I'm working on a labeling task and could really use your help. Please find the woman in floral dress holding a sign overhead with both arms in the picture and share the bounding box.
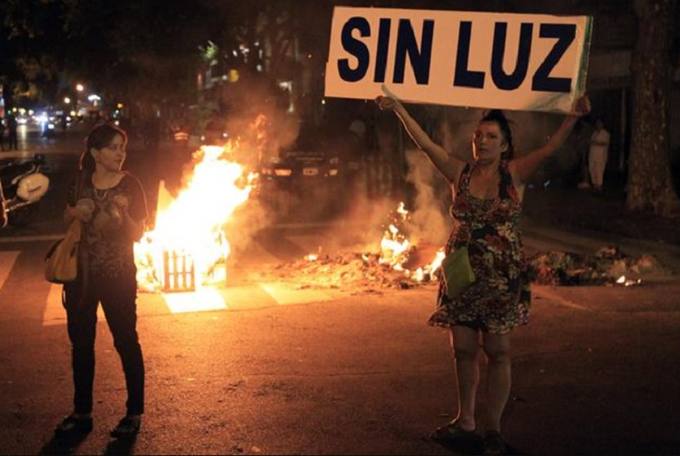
[376,89,590,454]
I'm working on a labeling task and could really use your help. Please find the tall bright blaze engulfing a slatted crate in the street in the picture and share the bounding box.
[135,142,256,291]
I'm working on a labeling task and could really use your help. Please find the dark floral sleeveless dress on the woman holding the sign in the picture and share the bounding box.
[429,160,531,334]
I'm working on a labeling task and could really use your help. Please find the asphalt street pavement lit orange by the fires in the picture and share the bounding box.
[0,128,680,455]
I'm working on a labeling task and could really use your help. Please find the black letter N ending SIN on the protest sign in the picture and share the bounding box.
[393,19,434,84]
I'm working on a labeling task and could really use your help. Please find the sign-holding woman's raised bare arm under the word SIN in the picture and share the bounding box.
[375,96,465,183]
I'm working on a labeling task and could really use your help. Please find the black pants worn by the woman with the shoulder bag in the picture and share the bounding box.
[64,273,144,415]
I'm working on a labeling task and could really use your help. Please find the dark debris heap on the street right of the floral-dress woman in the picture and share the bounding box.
[529,246,663,286]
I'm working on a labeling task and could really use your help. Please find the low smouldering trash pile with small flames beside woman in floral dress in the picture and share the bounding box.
[250,202,444,291]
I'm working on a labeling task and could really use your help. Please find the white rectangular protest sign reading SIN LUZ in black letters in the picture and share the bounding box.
[325,7,592,112]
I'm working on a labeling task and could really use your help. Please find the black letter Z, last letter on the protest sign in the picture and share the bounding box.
[531,24,576,93]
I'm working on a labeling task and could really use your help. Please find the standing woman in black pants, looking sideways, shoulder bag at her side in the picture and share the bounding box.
[55,124,147,438]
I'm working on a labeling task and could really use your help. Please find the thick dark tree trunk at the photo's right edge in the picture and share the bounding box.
[626,0,680,216]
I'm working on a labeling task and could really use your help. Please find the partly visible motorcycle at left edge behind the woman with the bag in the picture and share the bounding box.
[0,154,50,228]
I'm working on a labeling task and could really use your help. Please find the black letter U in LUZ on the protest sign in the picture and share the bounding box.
[491,22,534,90]
